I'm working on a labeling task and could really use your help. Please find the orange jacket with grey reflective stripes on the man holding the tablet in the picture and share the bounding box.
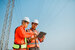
[27,29,43,48]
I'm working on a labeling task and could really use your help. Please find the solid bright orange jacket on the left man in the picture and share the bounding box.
[14,25,30,45]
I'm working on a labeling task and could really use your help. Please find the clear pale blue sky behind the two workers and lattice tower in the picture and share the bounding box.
[0,0,75,50]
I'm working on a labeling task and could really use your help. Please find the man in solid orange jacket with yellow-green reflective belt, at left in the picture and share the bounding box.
[13,17,31,50]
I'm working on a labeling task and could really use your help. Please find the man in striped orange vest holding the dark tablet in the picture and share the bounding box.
[26,19,45,50]
